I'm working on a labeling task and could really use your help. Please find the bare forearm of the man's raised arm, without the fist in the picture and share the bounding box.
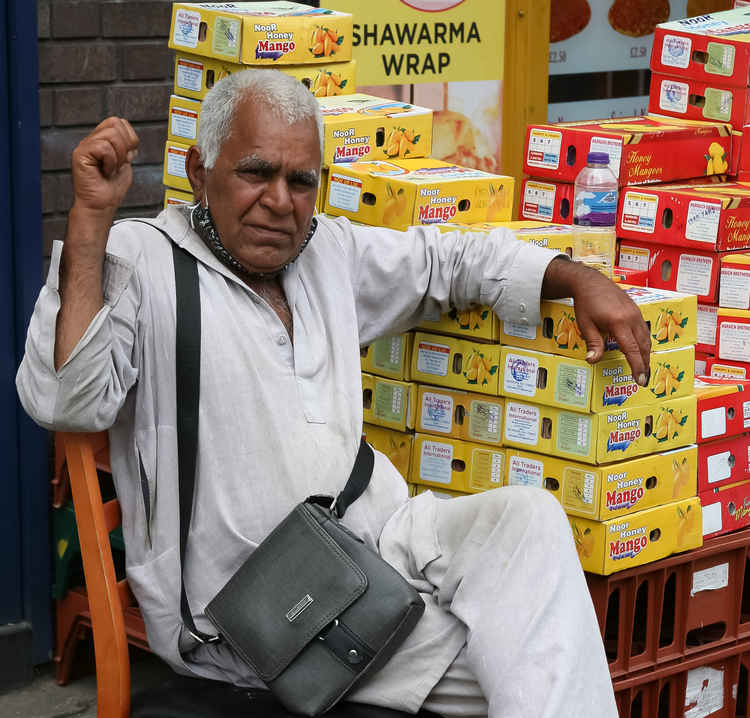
[55,206,112,370]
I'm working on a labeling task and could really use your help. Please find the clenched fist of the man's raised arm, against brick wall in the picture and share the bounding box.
[72,117,138,224]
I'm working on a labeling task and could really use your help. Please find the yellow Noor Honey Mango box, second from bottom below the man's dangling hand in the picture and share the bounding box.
[505,444,698,521]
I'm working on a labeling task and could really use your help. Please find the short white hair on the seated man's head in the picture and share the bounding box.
[197,69,323,170]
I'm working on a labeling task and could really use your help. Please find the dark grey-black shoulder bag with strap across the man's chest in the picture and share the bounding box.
[172,243,424,716]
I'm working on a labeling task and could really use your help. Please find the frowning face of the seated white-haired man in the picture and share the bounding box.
[205,98,321,272]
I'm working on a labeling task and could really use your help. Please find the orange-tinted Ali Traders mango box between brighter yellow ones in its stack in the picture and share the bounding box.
[416,384,503,446]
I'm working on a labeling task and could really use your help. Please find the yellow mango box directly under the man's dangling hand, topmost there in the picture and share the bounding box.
[500,285,698,358]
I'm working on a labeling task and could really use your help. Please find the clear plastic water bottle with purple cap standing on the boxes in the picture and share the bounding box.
[573,152,617,278]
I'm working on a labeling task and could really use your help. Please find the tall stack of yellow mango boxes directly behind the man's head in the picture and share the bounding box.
[164,0,356,208]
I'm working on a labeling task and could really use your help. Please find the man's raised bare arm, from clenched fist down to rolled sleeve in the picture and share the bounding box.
[55,117,138,369]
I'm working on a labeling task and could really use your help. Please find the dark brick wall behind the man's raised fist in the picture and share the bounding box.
[38,0,178,257]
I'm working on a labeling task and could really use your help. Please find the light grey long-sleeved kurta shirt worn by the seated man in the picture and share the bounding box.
[17,208,556,710]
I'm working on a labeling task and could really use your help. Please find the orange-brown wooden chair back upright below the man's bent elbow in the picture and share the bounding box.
[55,432,130,718]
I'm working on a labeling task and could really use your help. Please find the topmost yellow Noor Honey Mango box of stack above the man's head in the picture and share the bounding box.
[169,2,352,66]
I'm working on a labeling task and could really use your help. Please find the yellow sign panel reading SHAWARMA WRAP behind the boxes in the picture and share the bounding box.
[328,0,505,85]
